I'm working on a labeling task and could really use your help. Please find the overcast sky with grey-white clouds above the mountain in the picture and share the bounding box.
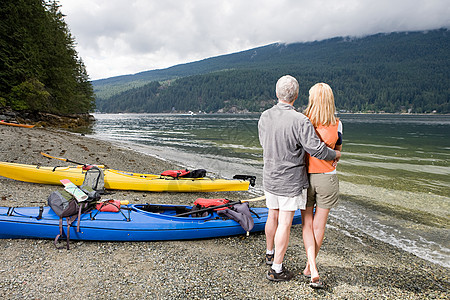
[60,0,450,80]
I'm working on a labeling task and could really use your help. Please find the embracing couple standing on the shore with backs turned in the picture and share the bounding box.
[258,75,342,288]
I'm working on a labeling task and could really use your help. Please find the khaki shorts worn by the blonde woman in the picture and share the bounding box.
[306,174,339,209]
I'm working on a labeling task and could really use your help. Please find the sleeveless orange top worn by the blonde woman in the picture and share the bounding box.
[307,120,339,173]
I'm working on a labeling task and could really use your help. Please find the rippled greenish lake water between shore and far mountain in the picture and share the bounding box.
[89,114,450,267]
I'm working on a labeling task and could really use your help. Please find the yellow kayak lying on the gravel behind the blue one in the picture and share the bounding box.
[0,162,250,192]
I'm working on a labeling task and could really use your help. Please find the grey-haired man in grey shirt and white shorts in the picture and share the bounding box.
[258,75,341,281]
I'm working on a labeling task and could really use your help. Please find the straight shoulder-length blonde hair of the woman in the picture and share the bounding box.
[304,82,336,127]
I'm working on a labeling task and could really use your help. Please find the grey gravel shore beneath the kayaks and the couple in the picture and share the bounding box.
[0,126,450,299]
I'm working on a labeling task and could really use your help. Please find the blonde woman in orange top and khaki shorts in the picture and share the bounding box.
[301,83,342,288]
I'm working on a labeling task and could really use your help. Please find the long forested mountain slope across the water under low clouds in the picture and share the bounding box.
[93,29,450,113]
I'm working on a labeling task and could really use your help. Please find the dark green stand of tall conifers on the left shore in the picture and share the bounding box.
[0,0,95,114]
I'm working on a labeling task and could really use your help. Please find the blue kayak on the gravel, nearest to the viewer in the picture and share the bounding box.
[0,204,301,241]
